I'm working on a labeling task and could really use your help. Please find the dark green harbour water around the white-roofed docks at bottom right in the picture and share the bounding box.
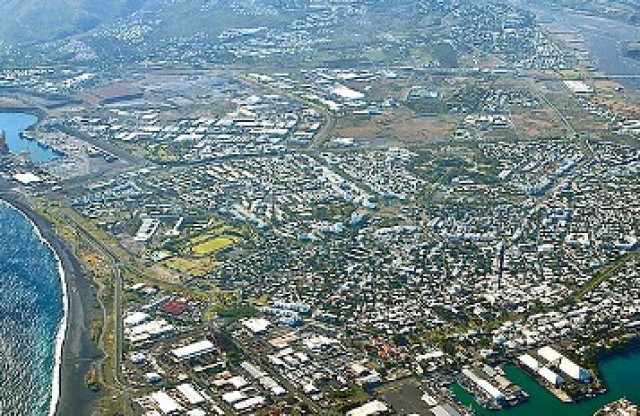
[451,352,640,416]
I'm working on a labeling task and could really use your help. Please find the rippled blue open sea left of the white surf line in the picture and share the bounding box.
[0,201,64,416]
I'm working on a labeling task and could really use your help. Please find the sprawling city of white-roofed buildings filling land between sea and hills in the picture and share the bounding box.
[0,0,640,416]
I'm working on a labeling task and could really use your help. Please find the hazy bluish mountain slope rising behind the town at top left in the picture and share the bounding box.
[0,0,308,44]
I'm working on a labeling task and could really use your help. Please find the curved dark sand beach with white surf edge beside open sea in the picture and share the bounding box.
[0,186,102,416]
